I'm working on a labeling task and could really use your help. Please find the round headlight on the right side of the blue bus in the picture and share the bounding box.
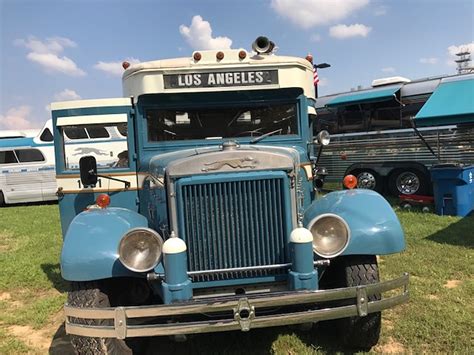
[308,213,350,258]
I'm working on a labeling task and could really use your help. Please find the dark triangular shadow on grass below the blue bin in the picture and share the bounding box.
[427,216,474,249]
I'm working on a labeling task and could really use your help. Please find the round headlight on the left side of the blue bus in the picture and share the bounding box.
[118,228,163,272]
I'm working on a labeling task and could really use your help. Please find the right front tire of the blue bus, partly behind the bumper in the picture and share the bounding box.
[322,255,382,351]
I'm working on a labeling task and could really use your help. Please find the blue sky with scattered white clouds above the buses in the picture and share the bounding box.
[0,0,474,129]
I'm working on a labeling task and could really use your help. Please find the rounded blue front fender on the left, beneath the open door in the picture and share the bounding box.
[61,207,148,281]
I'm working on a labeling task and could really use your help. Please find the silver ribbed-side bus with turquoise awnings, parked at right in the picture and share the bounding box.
[315,74,474,196]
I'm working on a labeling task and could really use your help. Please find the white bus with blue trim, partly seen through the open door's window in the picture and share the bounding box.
[0,120,127,205]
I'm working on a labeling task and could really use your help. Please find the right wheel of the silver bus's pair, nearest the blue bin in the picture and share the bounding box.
[388,169,429,197]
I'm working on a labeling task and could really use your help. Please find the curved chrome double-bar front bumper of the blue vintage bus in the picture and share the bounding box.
[64,273,409,339]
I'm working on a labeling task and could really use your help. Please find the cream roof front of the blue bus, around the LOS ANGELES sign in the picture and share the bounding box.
[122,49,315,100]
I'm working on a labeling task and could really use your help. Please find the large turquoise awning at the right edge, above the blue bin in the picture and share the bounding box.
[415,75,474,126]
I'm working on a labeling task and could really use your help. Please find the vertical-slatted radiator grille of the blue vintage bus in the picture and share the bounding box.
[178,177,287,282]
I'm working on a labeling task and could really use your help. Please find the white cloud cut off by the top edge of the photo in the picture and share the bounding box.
[271,0,369,28]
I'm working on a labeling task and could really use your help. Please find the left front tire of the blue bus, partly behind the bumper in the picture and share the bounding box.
[67,279,150,355]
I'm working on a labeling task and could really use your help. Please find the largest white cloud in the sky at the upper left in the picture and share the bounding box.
[14,37,86,76]
